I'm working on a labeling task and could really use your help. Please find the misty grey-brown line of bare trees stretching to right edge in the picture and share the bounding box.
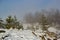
[24,9,60,30]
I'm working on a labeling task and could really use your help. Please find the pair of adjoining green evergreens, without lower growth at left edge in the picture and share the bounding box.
[6,16,23,29]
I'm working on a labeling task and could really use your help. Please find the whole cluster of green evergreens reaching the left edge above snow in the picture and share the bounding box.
[0,16,23,29]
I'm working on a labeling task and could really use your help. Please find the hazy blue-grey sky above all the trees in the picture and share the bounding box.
[0,0,60,19]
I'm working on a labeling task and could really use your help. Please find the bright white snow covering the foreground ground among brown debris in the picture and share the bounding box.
[0,28,60,40]
